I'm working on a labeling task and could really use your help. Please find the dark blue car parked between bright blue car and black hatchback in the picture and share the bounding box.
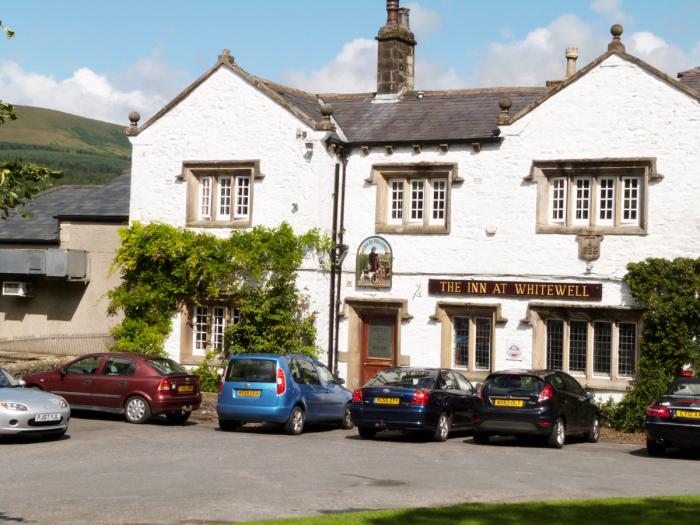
[352,367,476,441]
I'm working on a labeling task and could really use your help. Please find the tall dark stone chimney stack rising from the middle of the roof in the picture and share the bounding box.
[376,0,416,95]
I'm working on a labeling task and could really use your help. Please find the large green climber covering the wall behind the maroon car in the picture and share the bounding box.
[108,222,330,355]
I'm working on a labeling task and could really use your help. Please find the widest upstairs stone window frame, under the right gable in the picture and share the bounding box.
[525,157,663,235]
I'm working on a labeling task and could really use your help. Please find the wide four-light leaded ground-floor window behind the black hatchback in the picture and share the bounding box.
[543,312,639,378]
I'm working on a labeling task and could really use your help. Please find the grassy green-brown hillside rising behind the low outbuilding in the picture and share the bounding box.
[0,106,131,184]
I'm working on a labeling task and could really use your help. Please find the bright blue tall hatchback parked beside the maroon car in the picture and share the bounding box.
[216,354,353,435]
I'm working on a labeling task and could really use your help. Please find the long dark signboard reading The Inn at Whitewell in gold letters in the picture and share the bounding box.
[428,279,603,301]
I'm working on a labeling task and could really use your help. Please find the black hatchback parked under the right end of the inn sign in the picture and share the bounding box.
[473,370,600,448]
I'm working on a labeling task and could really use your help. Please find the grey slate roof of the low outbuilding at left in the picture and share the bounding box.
[0,171,131,244]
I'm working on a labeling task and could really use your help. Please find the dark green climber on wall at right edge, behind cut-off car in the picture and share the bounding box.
[608,258,700,431]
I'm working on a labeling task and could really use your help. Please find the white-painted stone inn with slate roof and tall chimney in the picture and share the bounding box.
[129,1,700,393]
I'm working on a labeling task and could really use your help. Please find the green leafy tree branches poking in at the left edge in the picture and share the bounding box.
[0,20,63,216]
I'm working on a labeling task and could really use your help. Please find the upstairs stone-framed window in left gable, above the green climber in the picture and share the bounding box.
[183,161,262,228]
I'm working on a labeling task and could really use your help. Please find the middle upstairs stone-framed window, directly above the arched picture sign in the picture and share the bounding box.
[366,163,463,234]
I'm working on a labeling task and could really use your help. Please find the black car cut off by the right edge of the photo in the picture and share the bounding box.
[647,377,700,456]
